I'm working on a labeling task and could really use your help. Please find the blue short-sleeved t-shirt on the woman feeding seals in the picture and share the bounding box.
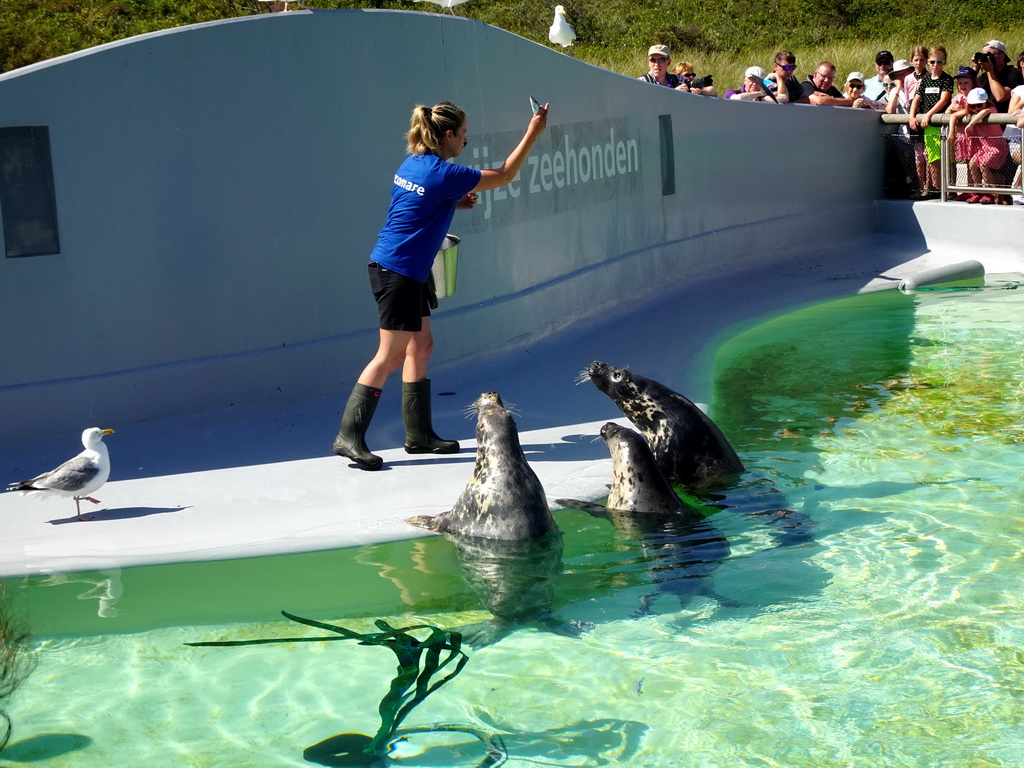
[370,155,482,283]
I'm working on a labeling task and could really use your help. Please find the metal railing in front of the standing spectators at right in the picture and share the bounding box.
[881,114,1024,201]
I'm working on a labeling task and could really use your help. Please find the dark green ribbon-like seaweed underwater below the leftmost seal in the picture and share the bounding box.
[185,610,508,768]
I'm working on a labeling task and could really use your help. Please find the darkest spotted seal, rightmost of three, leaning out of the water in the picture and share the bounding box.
[583,360,743,488]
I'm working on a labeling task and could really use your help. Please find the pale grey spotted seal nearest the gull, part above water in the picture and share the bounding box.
[406,392,557,541]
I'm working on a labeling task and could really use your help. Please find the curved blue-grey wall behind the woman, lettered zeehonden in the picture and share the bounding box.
[0,11,882,439]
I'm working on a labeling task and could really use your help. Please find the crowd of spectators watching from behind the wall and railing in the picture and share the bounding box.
[638,40,1024,205]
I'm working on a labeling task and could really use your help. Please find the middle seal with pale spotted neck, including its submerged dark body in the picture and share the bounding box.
[556,422,732,615]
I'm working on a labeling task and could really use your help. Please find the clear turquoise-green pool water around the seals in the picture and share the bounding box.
[0,278,1024,768]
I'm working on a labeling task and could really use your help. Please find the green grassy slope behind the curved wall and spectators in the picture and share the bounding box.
[0,0,1024,92]
